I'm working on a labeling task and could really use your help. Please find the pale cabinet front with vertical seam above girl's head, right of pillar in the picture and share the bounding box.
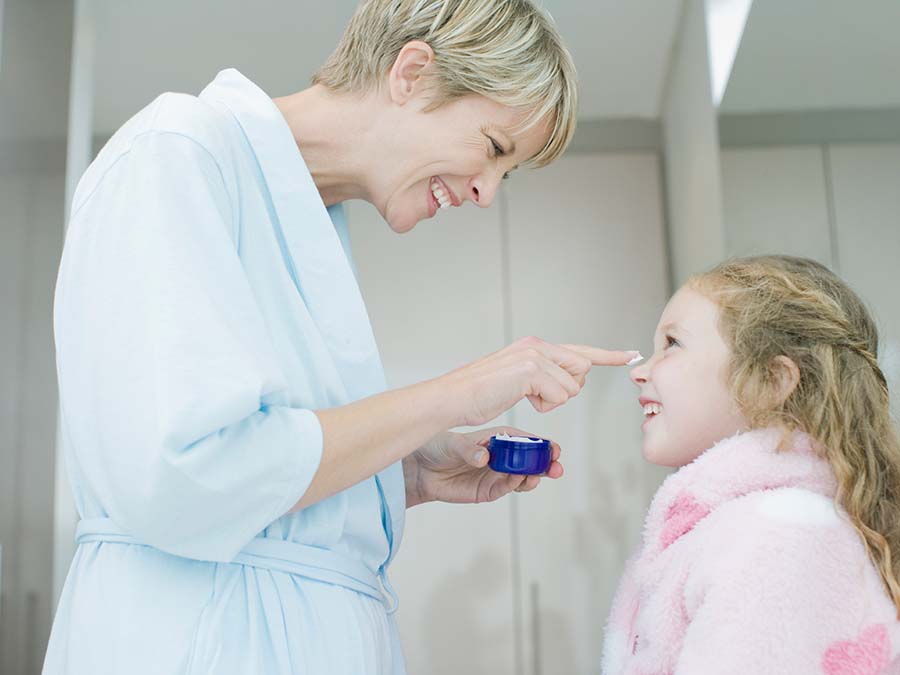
[722,144,900,419]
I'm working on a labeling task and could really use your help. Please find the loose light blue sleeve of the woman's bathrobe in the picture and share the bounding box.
[55,131,322,561]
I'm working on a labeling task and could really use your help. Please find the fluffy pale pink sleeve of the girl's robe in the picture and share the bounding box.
[675,496,880,675]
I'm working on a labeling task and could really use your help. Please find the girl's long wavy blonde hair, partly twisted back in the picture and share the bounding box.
[688,255,900,618]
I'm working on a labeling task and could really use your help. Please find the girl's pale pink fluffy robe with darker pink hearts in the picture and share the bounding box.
[603,429,900,675]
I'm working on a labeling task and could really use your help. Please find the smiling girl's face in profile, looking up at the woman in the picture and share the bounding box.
[631,287,747,467]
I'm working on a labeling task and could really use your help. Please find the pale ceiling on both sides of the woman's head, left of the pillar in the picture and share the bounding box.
[94,0,682,133]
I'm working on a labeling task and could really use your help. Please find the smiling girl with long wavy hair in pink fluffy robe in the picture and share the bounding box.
[603,256,900,675]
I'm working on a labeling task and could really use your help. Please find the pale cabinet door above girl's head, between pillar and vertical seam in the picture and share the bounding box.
[721,147,832,266]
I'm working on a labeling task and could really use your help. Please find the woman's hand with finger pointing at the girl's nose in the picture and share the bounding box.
[438,337,639,426]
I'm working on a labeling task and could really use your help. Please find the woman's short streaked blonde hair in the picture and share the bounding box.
[313,0,578,166]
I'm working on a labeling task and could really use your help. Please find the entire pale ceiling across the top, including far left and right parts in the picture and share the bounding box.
[0,0,900,139]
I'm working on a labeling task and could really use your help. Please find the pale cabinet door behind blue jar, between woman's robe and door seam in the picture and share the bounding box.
[348,202,513,675]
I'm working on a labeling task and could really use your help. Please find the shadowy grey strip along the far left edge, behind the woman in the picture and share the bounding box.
[0,0,72,675]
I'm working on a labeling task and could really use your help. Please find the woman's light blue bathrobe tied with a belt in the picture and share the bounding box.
[44,70,406,675]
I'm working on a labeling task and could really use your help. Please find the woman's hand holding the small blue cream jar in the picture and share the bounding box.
[403,427,563,508]
